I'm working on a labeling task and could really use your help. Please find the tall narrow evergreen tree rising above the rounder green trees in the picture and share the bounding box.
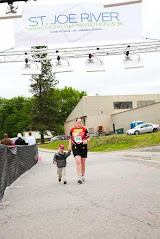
[30,46,58,143]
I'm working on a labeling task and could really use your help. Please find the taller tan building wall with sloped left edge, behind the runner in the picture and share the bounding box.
[65,94,159,135]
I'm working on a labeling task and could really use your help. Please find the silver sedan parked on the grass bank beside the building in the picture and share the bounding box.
[126,123,159,135]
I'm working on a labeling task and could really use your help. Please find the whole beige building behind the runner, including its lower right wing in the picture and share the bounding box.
[64,94,160,135]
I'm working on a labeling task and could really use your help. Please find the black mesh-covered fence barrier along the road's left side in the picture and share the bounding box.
[0,144,38,202]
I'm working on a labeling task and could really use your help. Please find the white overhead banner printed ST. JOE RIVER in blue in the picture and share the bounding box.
[14,3,142,47]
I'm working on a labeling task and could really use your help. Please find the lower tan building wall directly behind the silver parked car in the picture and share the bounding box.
[111,103,160,133]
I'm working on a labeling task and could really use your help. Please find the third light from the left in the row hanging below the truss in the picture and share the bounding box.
[85,54,105,72]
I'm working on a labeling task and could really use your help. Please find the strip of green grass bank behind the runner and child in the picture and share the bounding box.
[39,132,160,152]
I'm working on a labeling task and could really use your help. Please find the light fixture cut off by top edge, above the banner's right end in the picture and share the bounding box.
[103,0,143,7]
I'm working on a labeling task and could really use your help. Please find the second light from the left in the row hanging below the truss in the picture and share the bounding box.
[52,55,73,73]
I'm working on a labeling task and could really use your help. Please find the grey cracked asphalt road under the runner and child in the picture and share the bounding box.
[0,146,160,239]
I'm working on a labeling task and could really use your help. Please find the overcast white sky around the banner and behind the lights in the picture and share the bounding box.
[0,0,160,99]
